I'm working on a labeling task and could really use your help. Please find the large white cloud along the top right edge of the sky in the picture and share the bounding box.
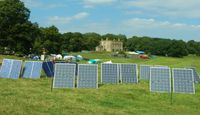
[124,0,200,18]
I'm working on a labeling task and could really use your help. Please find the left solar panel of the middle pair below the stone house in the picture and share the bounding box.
[101,64,119,84]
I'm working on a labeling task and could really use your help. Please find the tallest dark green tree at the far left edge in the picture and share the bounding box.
[0,0,32,53]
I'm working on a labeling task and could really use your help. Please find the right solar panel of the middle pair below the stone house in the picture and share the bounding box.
[119,63,138,83]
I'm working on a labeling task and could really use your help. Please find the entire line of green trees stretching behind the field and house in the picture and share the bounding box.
[0,0,200,57]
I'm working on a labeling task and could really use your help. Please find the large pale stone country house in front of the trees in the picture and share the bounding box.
[96,38,123,52]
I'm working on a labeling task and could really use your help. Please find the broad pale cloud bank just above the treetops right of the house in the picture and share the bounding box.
[123,18,200,39]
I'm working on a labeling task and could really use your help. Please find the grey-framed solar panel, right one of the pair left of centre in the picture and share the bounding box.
[77,64,98,88]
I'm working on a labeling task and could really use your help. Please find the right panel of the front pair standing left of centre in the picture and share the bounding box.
[77,64,98,88]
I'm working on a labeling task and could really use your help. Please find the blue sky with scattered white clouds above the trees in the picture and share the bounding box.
[22,0,200,41]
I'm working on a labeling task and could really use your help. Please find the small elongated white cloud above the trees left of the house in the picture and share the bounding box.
[48,12,89,25]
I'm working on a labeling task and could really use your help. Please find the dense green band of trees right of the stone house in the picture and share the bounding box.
[126,36,194,57]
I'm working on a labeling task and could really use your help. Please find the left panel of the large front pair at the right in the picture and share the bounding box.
[150,67,171,93]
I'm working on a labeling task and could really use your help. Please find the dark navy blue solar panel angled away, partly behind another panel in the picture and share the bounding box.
[42,61,54,77]
